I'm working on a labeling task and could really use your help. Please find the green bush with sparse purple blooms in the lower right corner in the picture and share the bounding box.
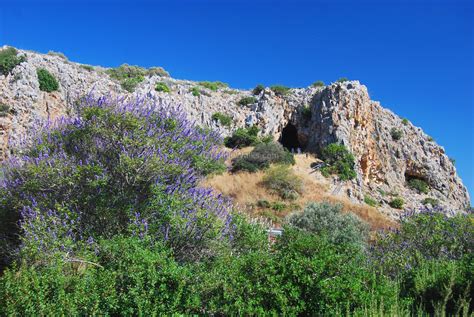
[371,208,474,316]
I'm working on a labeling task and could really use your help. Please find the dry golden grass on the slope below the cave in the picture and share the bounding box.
[202,148,397,230]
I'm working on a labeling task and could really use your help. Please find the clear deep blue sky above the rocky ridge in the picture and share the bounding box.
[0,0,474,200]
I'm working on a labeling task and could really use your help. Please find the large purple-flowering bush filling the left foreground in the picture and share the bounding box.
[0,95,232,264]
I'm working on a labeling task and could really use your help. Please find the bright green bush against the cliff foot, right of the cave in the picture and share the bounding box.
[321,143,357,180]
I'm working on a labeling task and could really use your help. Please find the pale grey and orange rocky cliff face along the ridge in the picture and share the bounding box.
[0,50,469,214]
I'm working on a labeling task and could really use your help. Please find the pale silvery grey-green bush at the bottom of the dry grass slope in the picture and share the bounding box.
[288,203,369,248]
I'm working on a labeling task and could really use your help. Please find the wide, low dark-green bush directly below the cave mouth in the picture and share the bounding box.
[232,142,295,172]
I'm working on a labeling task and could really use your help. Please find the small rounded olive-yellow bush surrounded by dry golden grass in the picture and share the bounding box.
[262,165,303,200]
